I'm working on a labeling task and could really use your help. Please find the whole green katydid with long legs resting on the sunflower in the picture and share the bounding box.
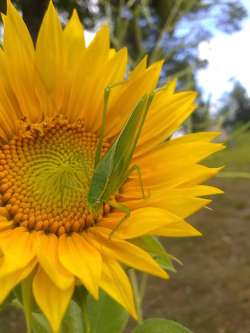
[87,88,153,237]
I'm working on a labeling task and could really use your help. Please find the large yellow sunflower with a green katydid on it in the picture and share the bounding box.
[0,2,222,332]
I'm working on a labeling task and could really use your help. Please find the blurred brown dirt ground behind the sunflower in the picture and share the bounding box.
[0,180,250,333]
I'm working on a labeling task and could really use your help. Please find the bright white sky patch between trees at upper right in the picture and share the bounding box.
[197,0,250,111]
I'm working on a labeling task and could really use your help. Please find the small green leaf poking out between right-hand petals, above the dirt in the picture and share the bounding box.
[132,236,176,272]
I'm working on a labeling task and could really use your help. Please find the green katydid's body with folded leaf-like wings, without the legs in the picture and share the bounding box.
[88,95,153,212]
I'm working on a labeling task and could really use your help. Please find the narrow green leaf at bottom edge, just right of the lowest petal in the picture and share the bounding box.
[60,301,84,333]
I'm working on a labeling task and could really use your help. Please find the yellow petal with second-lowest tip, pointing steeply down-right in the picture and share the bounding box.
[100,257,137,320]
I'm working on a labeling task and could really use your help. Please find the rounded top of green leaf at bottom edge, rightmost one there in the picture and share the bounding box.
[132,318,192,333]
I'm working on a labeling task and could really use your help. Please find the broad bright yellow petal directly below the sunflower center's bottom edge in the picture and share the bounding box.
[59,234,102,298]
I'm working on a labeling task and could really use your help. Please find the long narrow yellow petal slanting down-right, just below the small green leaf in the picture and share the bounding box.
[89,231,168,279]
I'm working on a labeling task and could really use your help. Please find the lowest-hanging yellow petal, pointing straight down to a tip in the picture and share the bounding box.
[33,269,74,333]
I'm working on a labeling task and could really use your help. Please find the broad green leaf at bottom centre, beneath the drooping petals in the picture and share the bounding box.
[88,291,129,333]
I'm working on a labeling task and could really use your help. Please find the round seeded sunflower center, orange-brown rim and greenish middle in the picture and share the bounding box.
[0,119,108,235]
